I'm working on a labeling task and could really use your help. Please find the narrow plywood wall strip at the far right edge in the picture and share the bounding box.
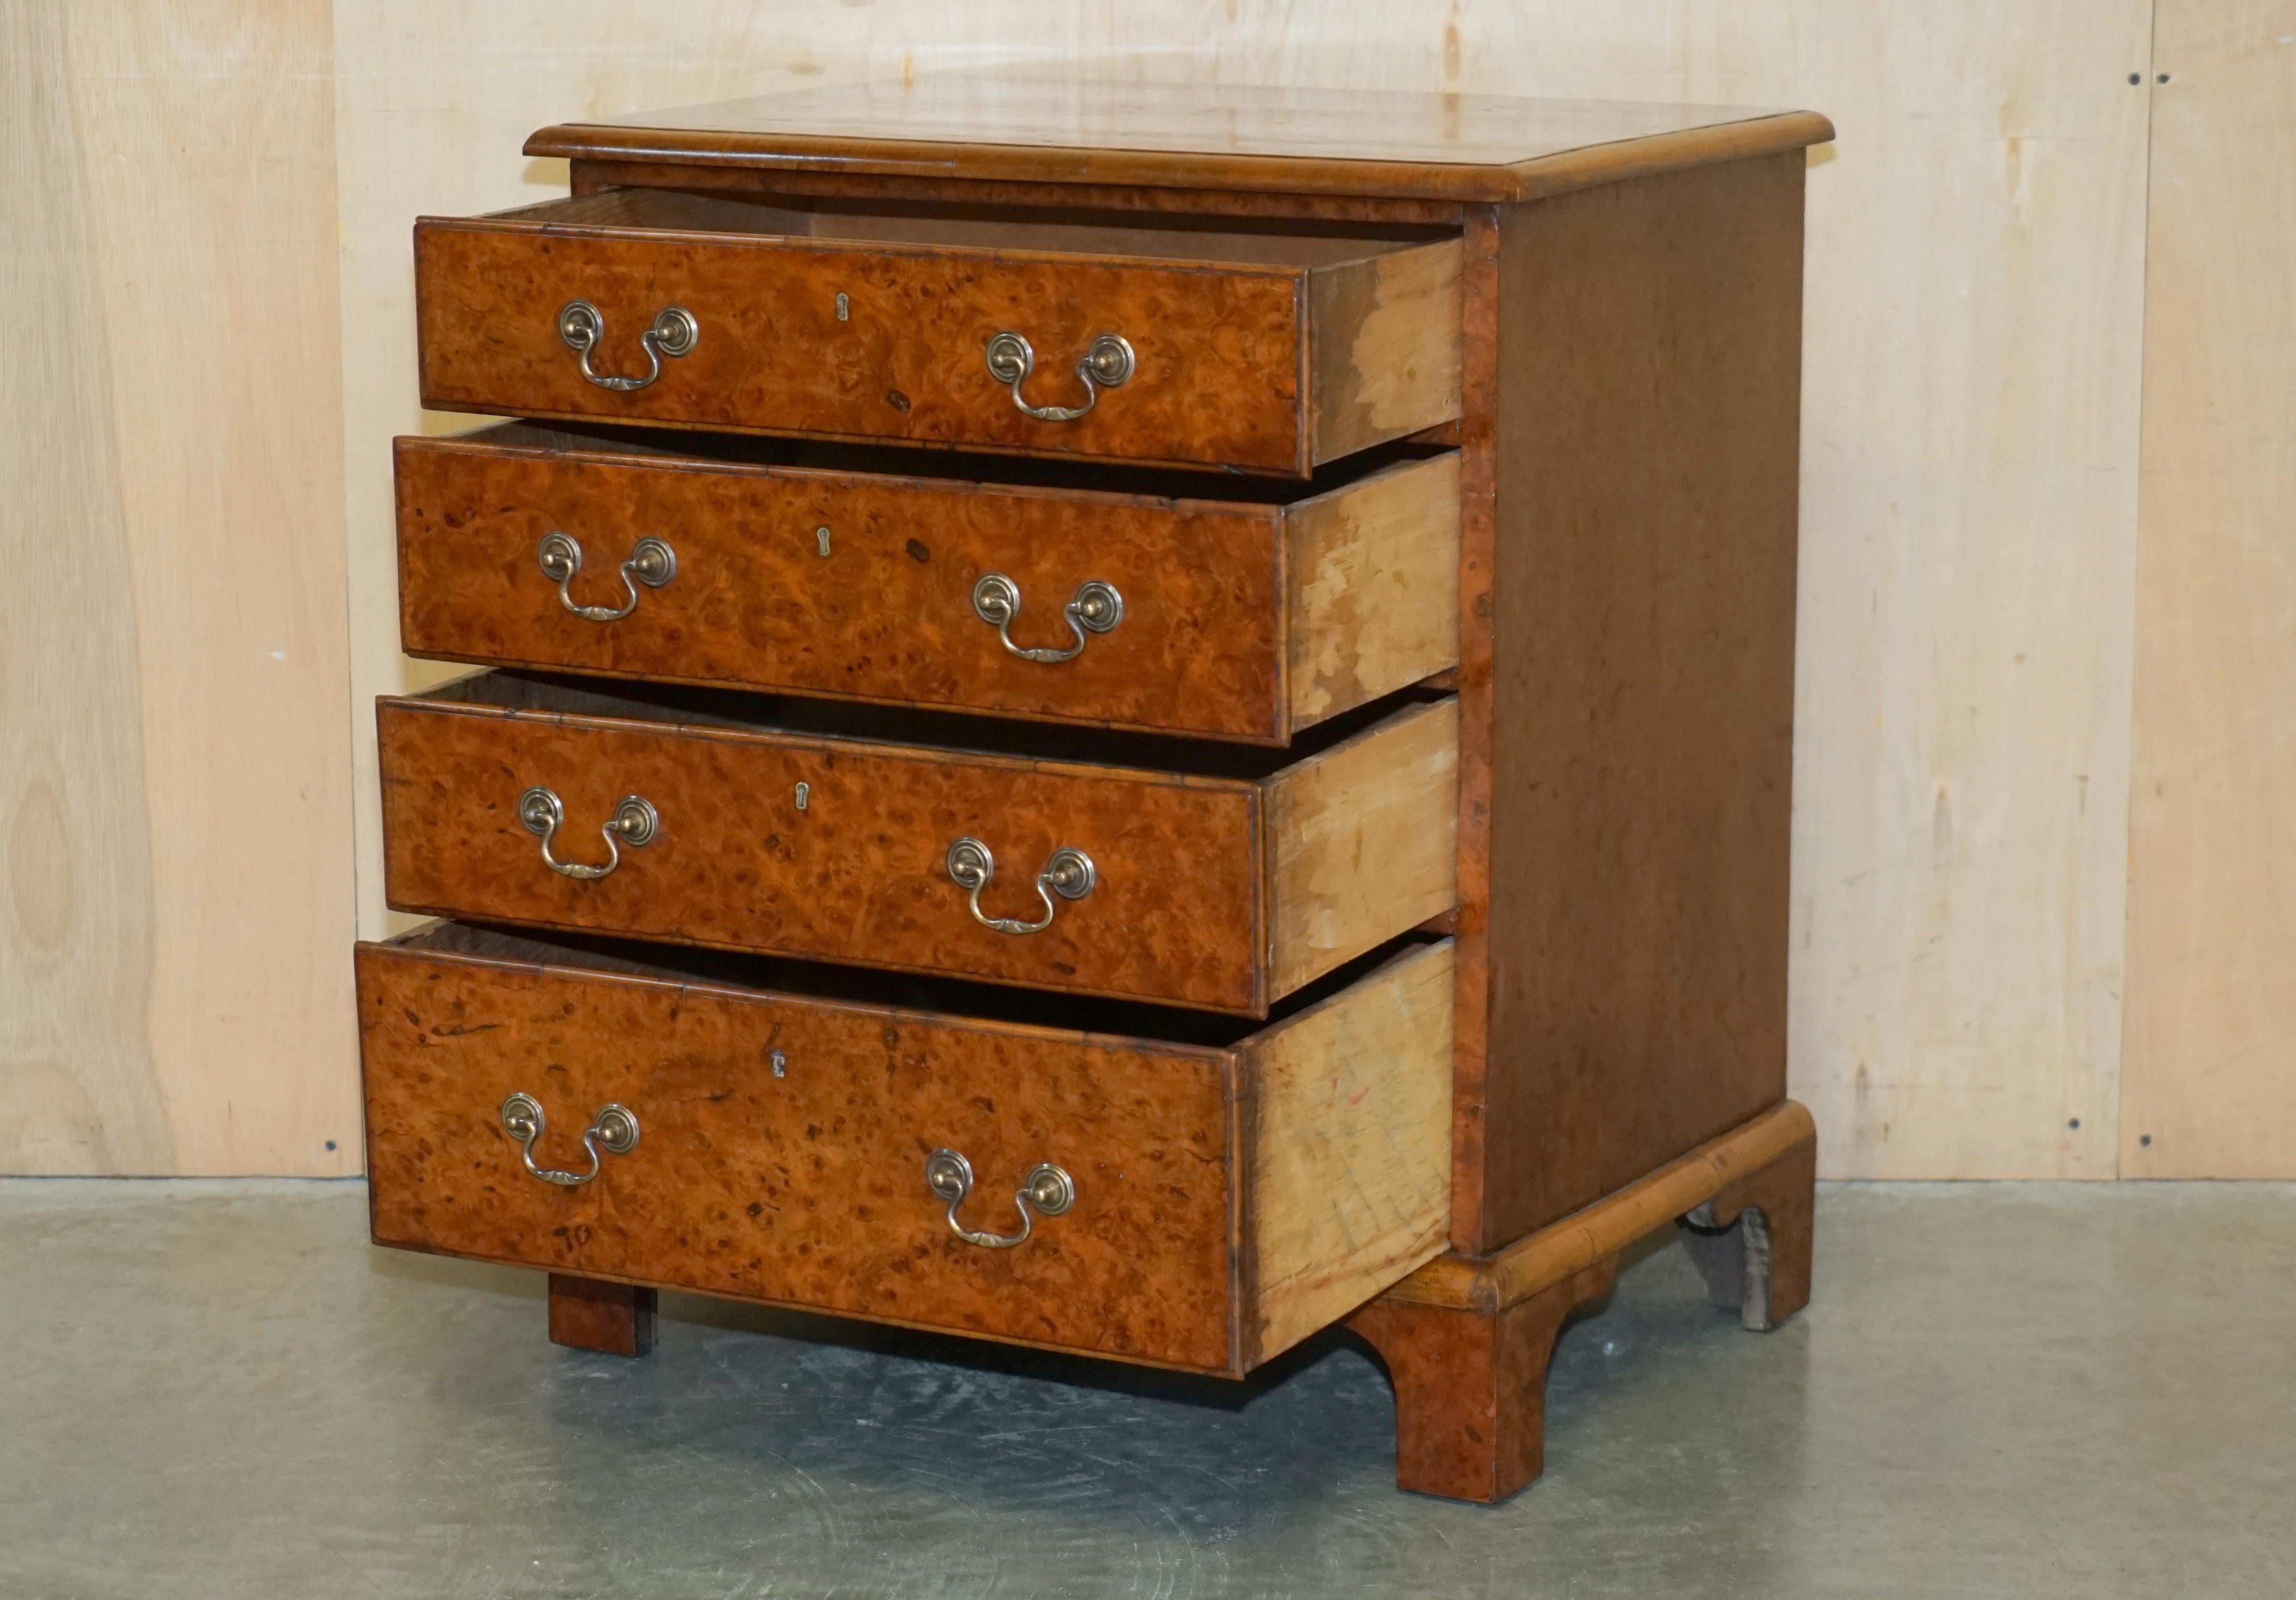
[2122,0,2296,1178]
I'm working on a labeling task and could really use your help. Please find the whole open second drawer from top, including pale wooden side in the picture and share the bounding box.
[397,425,1458,744]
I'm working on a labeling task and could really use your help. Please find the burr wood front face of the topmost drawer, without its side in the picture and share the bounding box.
[416,223,1307,473]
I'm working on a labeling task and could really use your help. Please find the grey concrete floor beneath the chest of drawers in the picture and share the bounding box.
[0,1180,2296,1600]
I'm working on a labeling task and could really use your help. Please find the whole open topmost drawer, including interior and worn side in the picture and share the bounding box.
[416,188,1460,475]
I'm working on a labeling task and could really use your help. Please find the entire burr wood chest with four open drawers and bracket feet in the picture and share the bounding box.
[358,76,1830,1499]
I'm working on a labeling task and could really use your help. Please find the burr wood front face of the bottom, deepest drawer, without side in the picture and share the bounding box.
[358,946,1233,1368]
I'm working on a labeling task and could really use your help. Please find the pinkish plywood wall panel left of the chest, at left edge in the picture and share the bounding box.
[0,0,358,1173]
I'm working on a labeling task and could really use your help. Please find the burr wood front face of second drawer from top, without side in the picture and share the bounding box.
[397,438,1286,739]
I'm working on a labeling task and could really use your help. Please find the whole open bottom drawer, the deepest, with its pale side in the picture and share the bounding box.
[358,923,1451,1373]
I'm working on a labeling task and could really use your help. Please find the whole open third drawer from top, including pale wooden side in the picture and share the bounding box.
[377,673,1458,1015]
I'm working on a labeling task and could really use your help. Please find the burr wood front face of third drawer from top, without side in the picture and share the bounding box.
[379,700,1265,1012]
